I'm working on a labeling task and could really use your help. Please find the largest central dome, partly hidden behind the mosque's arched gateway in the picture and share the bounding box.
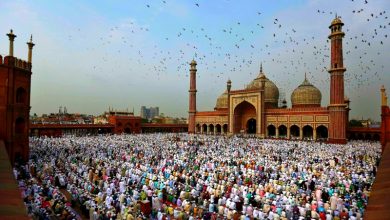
[246,67,279,106]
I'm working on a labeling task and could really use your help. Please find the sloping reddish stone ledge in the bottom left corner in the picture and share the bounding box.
[0,140,30,219]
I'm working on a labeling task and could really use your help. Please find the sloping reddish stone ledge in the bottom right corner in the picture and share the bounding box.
[364,143,390,220]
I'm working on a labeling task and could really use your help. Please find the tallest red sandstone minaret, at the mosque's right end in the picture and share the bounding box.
[328,15,347,144]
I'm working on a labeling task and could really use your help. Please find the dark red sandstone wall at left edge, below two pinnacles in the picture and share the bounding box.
[0,56,31,163]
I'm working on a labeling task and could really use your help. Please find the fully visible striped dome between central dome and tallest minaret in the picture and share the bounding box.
[291,74,322,107]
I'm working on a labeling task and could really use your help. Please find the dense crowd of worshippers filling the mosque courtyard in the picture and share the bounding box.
[15,134,381,220]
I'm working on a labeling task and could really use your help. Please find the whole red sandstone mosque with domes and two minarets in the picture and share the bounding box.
[188,16,350,144]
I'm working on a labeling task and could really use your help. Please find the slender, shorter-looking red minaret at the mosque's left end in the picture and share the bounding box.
[188,60,196,134]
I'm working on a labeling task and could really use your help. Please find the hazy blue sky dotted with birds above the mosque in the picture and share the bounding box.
[0,0,390,120]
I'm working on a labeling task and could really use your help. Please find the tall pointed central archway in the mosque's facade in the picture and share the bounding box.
[233,101,257,134]
